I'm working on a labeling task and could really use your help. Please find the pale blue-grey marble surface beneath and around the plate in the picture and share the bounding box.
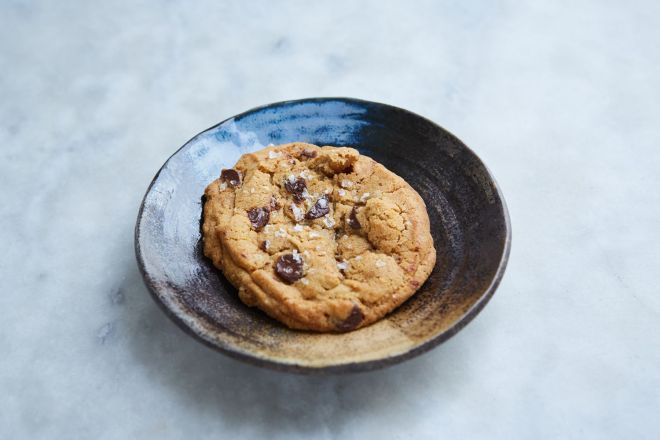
[0,0,660,439]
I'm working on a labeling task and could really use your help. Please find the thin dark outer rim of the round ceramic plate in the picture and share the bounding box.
[133,97,512,374]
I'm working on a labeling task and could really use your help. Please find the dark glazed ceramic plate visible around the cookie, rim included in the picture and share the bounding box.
[135,98,511,373]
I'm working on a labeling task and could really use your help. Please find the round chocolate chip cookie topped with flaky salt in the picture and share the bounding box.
[202,143,435,332]
